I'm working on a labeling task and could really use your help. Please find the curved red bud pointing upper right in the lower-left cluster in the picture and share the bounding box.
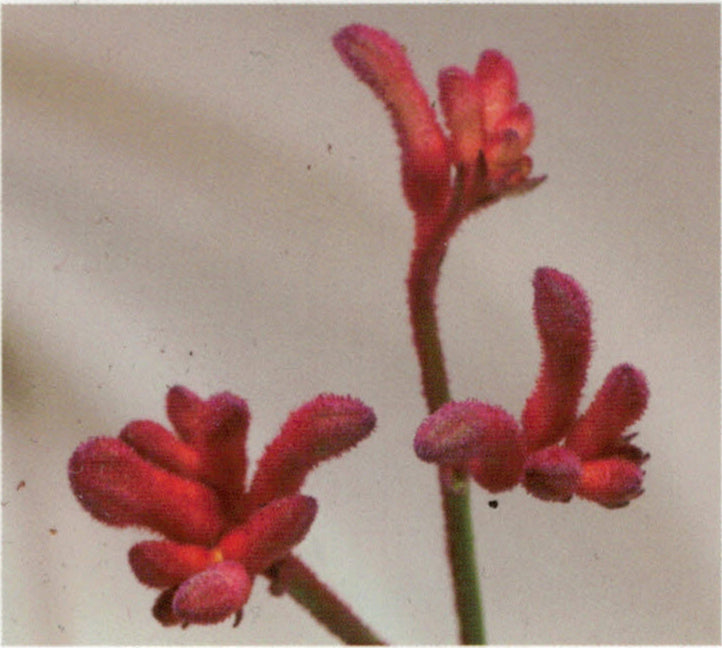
[249,394,376,507]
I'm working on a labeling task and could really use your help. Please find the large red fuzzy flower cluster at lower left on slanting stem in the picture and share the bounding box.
[68,386,376,625]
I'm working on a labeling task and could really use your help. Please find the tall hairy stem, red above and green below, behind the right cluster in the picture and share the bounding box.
[407,172,485,645]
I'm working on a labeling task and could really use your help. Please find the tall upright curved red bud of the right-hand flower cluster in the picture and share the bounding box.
[521,268,592,451]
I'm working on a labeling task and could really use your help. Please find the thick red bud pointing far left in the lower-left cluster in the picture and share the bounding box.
[68,437,225,544]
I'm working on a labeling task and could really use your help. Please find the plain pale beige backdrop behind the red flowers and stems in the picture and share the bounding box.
[2,5,720,644]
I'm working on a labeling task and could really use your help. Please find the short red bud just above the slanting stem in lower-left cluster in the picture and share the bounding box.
[218,495,318,574]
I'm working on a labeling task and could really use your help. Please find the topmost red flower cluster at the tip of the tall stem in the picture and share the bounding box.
[333,24,543,244]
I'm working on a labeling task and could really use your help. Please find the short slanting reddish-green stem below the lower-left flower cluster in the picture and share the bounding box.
[278,555,387,646]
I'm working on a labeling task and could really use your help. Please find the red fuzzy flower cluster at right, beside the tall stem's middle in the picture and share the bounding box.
[414,268,649,508]
